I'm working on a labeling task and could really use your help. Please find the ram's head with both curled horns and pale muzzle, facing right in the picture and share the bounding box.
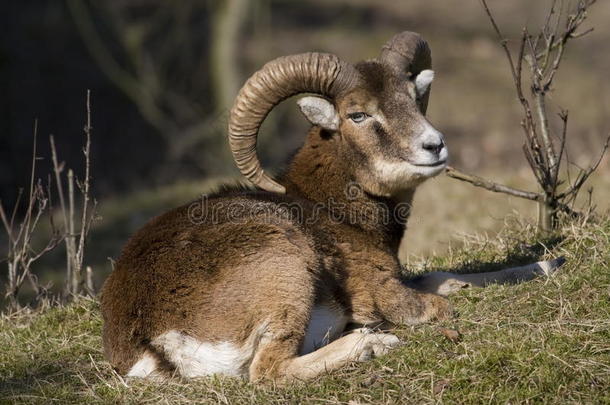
[229,32,447,196]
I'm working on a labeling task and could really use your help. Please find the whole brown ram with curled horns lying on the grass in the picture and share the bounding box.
[101,32,561,381]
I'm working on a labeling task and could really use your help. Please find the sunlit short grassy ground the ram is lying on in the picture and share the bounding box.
[0,218,610,404]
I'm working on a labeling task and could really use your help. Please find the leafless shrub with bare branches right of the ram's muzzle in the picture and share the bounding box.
[447,0,610,231]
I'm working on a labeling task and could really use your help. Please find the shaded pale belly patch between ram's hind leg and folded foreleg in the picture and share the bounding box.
[300,305,347,355]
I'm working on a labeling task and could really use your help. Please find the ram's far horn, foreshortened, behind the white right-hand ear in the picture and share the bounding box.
[379,31,432,114]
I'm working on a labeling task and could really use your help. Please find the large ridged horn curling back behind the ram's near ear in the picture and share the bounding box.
[229,52,357,193]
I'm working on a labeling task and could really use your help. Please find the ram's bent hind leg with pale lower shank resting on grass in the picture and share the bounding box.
[249,237,398,381]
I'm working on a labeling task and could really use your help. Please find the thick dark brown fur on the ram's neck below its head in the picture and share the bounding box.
[281,127,413,249]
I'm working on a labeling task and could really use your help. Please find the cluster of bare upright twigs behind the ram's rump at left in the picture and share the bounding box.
[0,91,96,310]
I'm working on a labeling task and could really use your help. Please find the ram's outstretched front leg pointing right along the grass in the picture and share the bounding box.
[408,256,566,296]
